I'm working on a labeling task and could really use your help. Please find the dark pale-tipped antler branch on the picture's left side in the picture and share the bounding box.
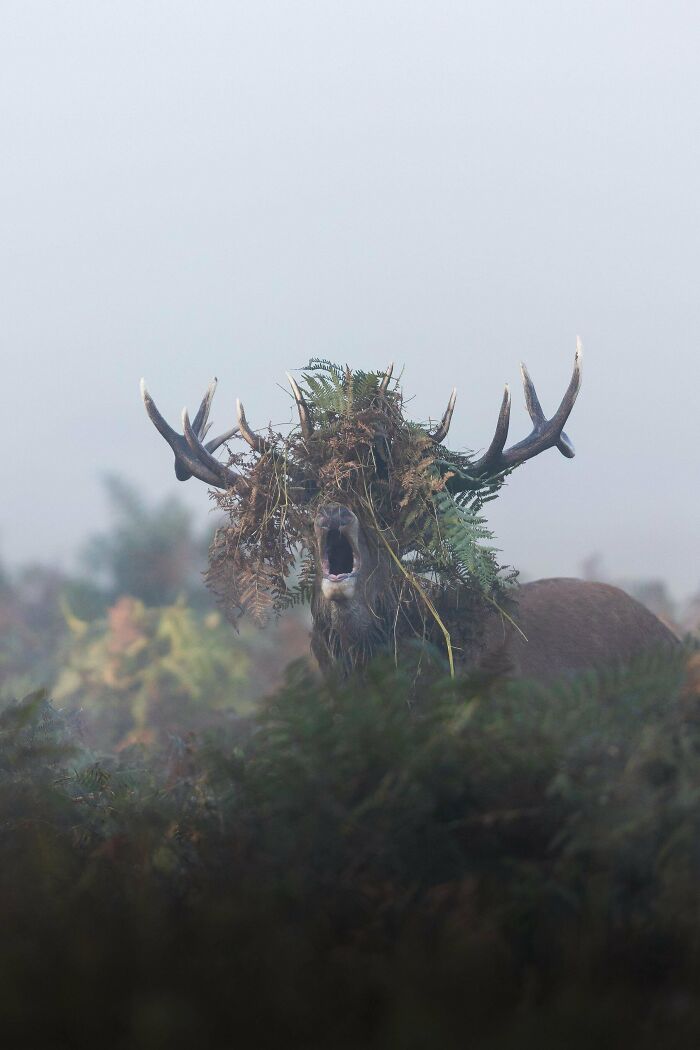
[141,378,248,490]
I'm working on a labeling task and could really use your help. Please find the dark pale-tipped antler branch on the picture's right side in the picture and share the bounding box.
[469,339,584,475]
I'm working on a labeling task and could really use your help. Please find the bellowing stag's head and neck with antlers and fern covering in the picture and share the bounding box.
[142,347,580,668]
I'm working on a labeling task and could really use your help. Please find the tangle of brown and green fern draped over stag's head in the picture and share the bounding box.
[207,362,512,631]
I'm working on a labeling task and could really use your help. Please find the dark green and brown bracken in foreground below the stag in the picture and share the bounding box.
[0,653,700,1050]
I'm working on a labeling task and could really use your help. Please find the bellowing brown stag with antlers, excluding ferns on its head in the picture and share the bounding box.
[142,345,676,679]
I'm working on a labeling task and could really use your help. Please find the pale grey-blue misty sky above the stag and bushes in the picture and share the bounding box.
[0,0,700,594]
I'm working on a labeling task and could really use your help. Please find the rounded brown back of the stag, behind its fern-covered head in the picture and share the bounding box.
[482,578,678,679]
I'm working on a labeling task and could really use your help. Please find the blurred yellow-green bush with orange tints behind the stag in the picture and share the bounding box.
[52,597,251,746]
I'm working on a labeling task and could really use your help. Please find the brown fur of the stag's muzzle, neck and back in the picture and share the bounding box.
[312,511,678,680]
